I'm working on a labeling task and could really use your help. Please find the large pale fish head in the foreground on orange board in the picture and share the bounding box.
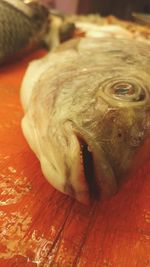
[21,38,150,203]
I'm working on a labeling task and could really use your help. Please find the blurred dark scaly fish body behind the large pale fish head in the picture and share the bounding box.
[0,0,48,64]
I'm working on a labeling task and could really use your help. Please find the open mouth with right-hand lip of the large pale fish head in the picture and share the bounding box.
[78,137,118,204]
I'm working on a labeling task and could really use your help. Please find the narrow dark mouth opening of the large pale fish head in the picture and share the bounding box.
[79,139,100,199]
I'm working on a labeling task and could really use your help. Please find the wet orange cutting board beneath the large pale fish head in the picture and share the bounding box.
[0,51,150,267]
